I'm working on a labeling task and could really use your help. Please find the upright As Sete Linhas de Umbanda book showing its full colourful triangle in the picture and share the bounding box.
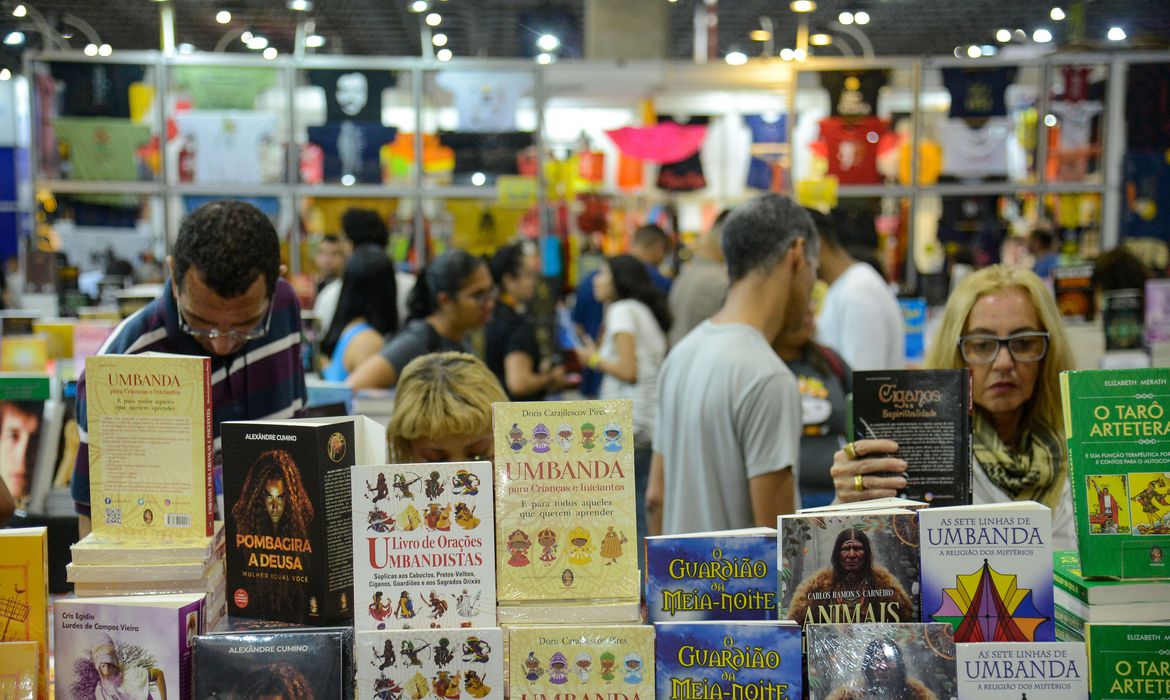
[918,501,1055,643]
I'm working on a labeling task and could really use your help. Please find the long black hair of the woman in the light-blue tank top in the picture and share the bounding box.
[321,246,398,355]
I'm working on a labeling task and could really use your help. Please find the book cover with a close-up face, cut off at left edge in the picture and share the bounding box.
[0,376,53,512]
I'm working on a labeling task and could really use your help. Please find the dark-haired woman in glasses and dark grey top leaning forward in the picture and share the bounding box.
[345,251,496,389]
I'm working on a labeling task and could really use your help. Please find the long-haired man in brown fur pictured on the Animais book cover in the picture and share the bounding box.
[786,528,915,625]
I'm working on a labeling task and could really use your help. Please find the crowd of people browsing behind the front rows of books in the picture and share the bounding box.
[66,194,1148,548]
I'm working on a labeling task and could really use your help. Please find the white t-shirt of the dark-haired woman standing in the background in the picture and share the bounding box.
[598,298,666,446]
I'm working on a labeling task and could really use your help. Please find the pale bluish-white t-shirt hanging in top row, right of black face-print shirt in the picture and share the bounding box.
[435,70,532,131]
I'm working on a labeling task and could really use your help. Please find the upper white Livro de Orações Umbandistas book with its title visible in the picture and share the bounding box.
[350,461,496,631]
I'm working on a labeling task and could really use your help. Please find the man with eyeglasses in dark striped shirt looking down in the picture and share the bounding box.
[71,201,305,536]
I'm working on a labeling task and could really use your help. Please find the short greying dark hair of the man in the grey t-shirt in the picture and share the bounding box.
[723,193,819,282]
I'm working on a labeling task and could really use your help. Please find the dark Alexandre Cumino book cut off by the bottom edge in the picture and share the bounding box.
[193,627,353,700]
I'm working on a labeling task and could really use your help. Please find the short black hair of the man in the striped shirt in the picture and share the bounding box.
[173,199,281,298]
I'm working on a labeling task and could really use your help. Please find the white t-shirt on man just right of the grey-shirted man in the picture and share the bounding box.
[817,262,906,370]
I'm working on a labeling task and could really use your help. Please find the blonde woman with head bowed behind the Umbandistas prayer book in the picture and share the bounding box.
[386,352,508,464]
